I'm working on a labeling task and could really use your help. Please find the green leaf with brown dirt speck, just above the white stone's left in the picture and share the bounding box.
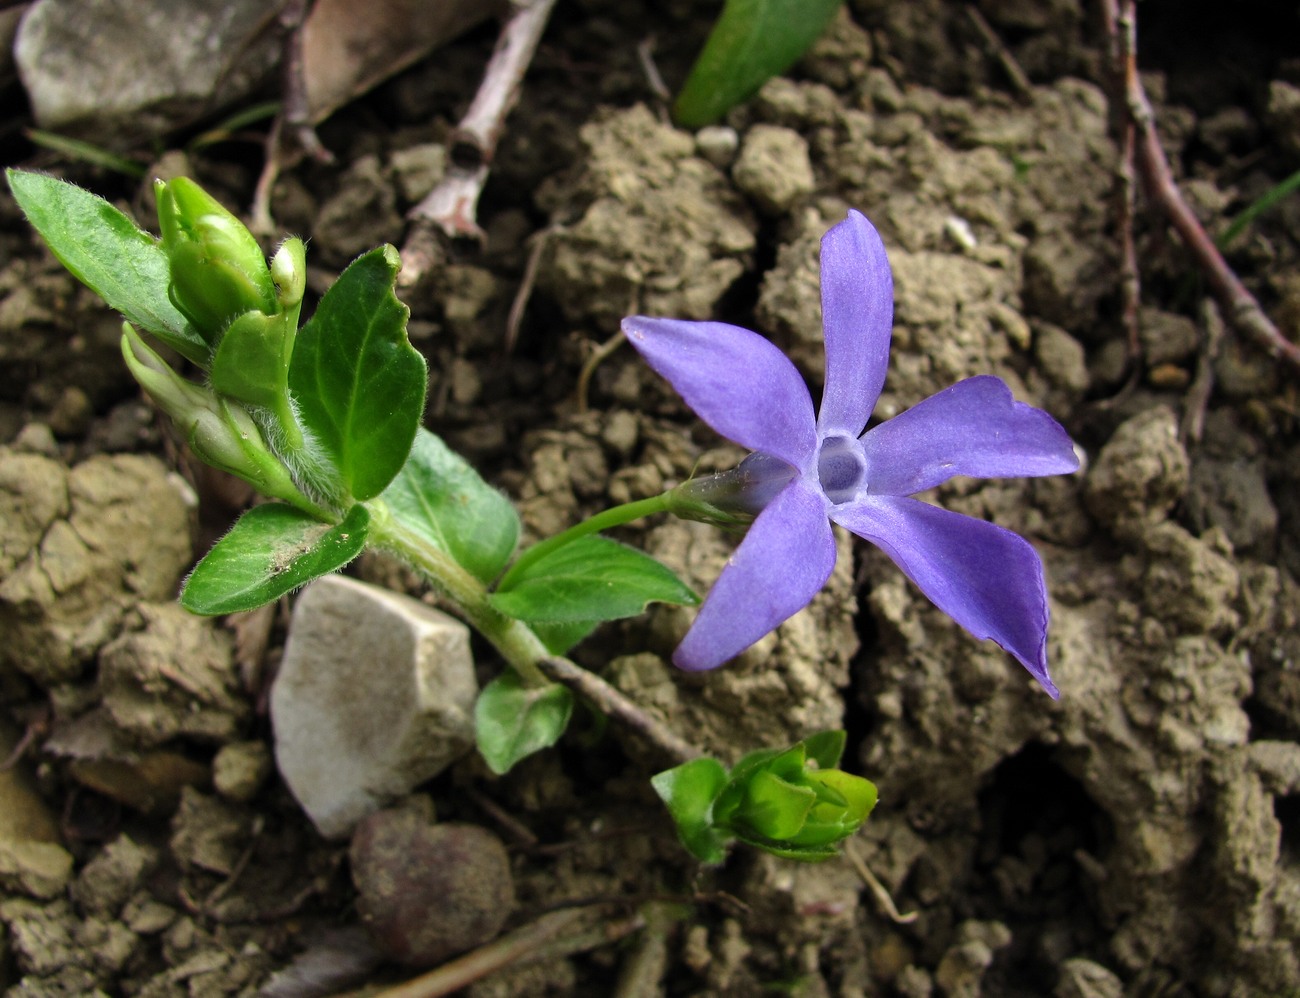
[181,503,371,616]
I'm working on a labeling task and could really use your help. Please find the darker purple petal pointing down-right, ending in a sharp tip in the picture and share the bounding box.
[831,495,1060,699]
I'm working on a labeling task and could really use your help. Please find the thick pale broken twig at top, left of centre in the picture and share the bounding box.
[398,0,555,287]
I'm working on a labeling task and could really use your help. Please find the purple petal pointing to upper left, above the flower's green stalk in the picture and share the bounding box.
[623,316,816,472]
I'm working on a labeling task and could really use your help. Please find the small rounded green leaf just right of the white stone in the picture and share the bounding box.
[475,672,573,776]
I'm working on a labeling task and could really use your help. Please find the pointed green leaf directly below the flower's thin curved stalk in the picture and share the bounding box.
[491,537,699,624]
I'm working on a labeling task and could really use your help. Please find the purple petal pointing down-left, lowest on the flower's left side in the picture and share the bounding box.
[672,478,835,672]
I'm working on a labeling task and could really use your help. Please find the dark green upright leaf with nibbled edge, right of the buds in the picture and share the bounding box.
[289,246,428,502]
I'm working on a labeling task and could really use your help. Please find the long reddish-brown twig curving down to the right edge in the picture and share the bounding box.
[1102,0,1300,370]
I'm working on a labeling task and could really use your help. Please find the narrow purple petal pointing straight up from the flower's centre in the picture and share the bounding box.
[818,212,893,437]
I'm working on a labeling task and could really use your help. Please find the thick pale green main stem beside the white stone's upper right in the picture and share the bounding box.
[367,500,551,686]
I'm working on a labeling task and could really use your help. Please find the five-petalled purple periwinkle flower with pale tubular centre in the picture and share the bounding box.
[623,212,1079,697]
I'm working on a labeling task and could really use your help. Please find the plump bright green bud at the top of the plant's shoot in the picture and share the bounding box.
[153,177,279,347]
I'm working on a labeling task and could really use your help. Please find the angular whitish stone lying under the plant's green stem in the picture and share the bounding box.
[270,576,478,838]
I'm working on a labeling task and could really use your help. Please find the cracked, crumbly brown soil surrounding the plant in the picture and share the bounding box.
[0,0,1300,998]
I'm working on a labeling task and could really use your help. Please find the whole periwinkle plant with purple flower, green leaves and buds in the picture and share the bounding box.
[8,170,1075,862]
